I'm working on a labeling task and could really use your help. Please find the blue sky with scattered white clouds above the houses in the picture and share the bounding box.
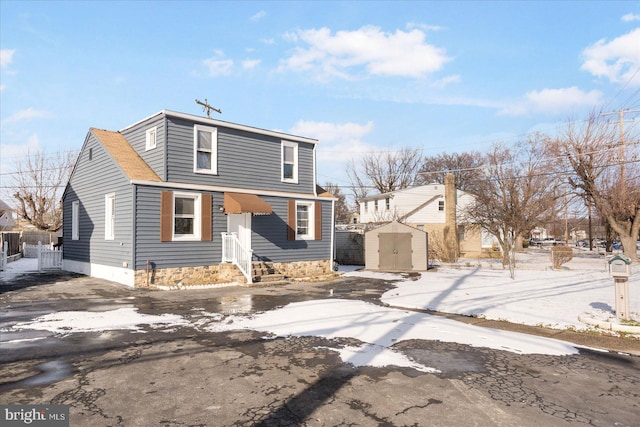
[0,0,640,199]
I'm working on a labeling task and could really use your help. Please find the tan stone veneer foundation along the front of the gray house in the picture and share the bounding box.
[134,260,332,288]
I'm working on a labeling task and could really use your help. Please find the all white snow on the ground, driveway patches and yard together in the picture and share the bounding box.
[0,255,640,372]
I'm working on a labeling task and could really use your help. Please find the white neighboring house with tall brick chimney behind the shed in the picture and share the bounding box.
[360,175,494,257]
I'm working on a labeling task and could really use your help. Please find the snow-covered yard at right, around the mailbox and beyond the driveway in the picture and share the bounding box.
[370,252,640,330]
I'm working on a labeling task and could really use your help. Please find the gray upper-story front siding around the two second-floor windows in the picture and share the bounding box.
[167,117,315,194]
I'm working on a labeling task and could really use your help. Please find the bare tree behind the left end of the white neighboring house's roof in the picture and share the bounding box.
[347,148,421,202]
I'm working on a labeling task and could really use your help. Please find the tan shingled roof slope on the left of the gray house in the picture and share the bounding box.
[90,128,162,182]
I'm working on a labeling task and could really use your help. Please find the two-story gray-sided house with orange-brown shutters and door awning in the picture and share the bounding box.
[63,110,335,287]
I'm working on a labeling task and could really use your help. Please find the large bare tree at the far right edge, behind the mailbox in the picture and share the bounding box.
[553,112,640,260]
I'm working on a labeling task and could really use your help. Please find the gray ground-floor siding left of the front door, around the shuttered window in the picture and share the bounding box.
[135,185,227,270]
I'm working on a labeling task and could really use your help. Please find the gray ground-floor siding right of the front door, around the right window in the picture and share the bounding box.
[251,197,333,262]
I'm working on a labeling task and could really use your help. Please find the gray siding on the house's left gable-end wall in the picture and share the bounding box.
[63,134,133,267]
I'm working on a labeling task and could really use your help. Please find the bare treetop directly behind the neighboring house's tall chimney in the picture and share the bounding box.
[416,151,485,193]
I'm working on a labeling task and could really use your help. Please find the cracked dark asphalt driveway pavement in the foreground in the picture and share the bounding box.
[0,274,640,427]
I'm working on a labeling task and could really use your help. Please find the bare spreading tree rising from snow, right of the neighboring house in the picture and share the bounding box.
[463,134,562,277]
